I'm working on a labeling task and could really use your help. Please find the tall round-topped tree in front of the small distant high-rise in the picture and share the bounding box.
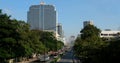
[74,25,106,63]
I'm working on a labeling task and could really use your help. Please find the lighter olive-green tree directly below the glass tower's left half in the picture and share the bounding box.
[29,30,46,53]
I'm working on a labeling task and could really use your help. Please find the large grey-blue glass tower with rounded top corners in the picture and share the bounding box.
[27,2,57,32]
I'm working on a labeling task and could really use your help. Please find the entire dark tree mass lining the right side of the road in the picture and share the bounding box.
[74,25,120,63]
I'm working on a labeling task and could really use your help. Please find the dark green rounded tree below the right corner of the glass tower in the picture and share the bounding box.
[40,32,57,52]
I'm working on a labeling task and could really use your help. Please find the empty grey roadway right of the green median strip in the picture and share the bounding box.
[57,50,81,63]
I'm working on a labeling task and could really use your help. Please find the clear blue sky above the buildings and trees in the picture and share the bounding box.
[0,0,120,37]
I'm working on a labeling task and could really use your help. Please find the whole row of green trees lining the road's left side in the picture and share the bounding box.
[0,10,63,62]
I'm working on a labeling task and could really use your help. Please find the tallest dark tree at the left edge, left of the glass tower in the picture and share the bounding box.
[0,12,31,61]
